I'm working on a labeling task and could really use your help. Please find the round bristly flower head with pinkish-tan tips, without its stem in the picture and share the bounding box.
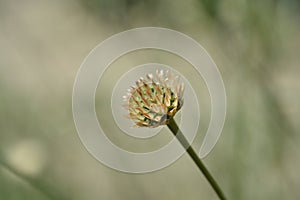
[123,70,184,128]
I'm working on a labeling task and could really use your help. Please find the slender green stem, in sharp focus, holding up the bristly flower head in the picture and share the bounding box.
[168,118,226,200]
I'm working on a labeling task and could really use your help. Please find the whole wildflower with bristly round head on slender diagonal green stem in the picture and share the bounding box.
[123,70,226,200]
